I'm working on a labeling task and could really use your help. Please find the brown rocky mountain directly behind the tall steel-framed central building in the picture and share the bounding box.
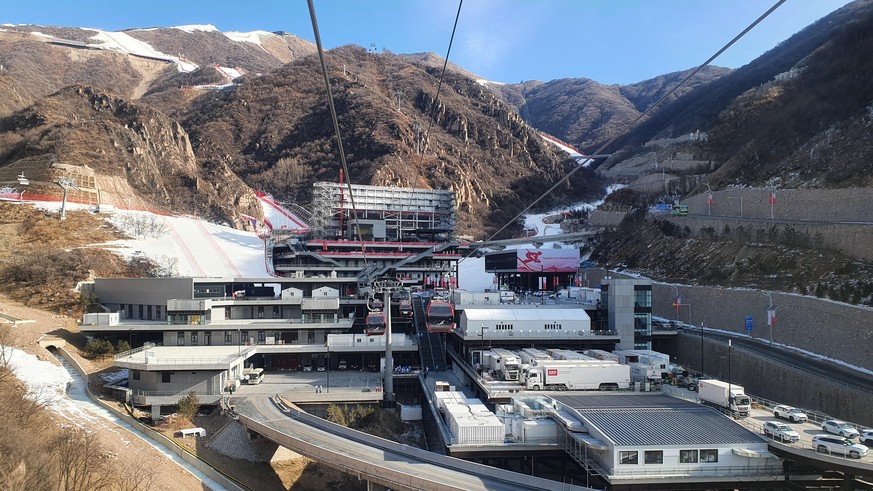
[183,46,602,237]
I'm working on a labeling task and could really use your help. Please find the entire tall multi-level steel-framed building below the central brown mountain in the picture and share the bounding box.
[267,182,461,292]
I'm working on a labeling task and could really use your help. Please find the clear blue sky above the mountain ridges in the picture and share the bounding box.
[0,0,848,84]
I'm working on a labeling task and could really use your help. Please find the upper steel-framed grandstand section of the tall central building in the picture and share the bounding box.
[310,182,455,242]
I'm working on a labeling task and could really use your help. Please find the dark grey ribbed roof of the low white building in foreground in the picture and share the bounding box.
[554,394,763,446]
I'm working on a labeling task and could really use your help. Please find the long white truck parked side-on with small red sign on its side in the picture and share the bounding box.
[522,360,630,390]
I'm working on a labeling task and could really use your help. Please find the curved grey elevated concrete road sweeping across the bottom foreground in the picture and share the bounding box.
[233,397,588,491]
